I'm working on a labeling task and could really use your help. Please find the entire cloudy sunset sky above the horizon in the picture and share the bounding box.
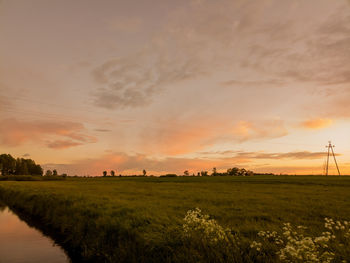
[0,0,350,176]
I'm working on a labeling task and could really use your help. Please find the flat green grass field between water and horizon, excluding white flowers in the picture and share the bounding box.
[0,176,350,262]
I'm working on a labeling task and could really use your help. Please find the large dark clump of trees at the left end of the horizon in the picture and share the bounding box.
[0,154,43,175]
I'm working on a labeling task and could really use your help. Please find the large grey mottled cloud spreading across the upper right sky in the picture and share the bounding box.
[92,0,350,114]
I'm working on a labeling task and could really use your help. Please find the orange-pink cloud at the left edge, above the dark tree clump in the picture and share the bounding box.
[0,119,97,149]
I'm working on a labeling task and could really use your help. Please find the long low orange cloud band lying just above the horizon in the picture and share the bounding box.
[44,152,340,176]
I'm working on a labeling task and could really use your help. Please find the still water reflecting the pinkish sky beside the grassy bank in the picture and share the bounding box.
[0,204,70,263]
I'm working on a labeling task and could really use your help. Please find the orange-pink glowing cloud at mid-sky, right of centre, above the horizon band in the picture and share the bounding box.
[140,117,288,155]
